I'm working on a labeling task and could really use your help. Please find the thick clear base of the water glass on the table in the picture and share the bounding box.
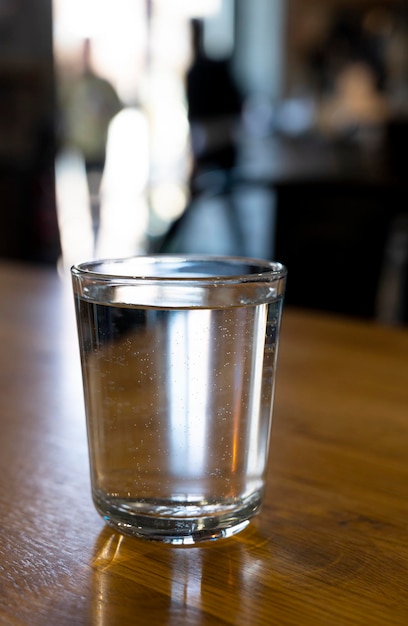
[94,493,261,545]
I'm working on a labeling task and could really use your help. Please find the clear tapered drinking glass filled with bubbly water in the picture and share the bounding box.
[71,255,286,544]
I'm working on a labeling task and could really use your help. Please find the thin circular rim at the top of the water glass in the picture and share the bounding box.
[71,253,287,284]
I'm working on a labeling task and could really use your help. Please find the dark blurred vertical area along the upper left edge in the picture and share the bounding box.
[0,0,59,263]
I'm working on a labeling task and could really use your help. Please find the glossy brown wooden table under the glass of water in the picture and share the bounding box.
[0,264,408,626]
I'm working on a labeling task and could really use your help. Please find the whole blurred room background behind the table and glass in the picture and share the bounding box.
[0,0,408,324]
